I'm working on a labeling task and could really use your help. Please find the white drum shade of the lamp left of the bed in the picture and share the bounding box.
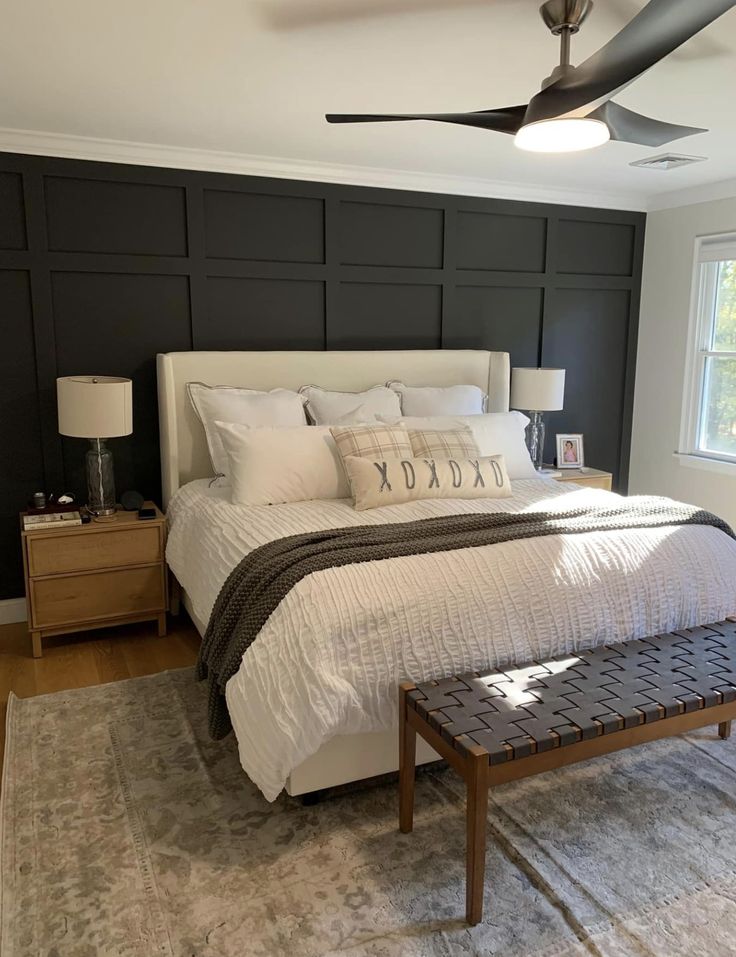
[56,375,133,439]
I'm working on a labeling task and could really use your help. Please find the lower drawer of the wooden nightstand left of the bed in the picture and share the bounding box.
[30,564,166,629]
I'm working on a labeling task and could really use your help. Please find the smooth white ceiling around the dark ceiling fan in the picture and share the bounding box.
[0,0,736,208]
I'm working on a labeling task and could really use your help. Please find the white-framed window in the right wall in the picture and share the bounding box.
[680,235,736,464]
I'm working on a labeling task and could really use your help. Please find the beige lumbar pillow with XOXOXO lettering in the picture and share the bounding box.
[343,455,511,511]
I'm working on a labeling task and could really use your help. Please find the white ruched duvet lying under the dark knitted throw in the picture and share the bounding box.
[166,479,736,800]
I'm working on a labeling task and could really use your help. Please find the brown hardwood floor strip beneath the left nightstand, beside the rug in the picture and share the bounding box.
[0,612,200,769]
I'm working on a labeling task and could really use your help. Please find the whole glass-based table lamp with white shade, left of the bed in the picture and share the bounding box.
[56,375,133,515]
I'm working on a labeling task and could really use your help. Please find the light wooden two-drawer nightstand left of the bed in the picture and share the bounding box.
[21,502,168,658]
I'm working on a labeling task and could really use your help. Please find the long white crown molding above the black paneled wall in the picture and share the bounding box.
[0,128,647,210]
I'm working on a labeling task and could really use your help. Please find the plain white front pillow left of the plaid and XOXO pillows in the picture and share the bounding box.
[215,422,350,505]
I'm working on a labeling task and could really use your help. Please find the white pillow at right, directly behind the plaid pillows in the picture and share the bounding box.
[382,412,539,480]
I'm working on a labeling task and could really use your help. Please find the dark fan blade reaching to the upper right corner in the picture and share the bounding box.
[525,0,736,123]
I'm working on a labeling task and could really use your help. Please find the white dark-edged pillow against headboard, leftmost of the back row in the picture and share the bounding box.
[187,382,307,475]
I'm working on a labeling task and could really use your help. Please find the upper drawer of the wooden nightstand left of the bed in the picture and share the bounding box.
[28,525,161,577]
